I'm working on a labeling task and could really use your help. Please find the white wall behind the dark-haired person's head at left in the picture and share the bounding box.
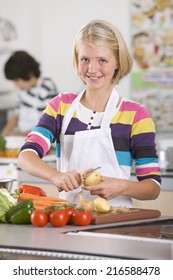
[0,0,42,91]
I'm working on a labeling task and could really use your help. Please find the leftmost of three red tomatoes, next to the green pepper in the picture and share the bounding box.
[30,210,49,227]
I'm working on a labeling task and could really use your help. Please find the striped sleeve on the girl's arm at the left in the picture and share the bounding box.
[21,93,76,158]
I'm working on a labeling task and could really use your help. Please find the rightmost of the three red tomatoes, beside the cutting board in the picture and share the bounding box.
[72,210,92,226]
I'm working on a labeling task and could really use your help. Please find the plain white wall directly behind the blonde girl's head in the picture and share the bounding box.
[42,0,130,95]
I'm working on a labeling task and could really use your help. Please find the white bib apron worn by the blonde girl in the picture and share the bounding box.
[57,89,132,207]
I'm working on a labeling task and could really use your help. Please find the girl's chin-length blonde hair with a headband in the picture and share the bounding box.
[73,20,133,84]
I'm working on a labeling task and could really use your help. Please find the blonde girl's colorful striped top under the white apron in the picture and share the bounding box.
[21,93,161,184]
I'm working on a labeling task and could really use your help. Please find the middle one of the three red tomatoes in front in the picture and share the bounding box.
[49,209,68,227]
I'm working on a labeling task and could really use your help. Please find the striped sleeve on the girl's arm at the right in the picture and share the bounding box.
[131,101,161,183]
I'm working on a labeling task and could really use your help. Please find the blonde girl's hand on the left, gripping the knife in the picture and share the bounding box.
[51,170,82,192]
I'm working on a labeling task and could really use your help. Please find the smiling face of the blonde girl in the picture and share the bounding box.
[78,42,118,90]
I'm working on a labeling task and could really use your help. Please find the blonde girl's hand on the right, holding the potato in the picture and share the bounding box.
[85,177,128,200]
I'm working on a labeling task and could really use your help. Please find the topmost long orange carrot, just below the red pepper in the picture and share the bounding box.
[19,193,68,202]
